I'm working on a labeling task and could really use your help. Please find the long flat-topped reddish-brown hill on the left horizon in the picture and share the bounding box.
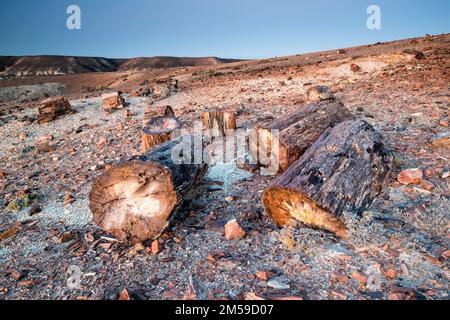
[0,56,239,77]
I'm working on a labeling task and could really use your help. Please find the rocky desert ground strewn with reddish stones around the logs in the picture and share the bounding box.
[0,35,450,300]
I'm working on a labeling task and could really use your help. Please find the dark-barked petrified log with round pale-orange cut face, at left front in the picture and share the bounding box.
[89,137,207,244]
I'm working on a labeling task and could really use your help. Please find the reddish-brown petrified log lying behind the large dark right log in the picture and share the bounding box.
[249,100,354,174]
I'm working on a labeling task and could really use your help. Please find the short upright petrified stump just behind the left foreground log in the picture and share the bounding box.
[142,117,181,153]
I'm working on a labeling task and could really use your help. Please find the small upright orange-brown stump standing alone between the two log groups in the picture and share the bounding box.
[200,110,236,138]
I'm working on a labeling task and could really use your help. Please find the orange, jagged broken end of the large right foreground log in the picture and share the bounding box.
[262,187,348,239]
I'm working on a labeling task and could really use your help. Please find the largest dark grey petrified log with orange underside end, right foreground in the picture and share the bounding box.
[262,120,393,238]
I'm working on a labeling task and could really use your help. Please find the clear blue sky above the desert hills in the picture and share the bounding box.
[0,0,450,58]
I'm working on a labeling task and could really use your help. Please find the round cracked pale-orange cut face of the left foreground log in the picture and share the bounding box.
[89,161,177,244]
